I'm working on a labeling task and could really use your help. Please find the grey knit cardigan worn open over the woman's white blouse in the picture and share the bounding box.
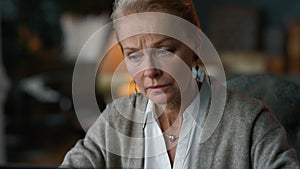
[60,92,300,169]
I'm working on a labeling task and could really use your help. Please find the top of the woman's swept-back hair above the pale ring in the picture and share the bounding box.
[111,0,200,28]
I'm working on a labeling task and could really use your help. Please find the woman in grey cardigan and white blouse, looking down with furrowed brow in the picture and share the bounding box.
[61,0,299,169]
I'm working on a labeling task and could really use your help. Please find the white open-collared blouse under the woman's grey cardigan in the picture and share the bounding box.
[144,80,210,169]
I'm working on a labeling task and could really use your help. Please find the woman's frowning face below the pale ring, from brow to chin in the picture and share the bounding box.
[120,34,193,104]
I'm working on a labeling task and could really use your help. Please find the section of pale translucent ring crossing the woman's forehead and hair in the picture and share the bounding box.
[113,12,202,49]
